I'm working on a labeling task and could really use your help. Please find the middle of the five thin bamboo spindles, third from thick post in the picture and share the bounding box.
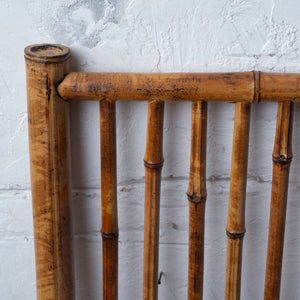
[187,101,207,300]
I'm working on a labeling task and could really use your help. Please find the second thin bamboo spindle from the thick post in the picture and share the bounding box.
[143,100,164,300]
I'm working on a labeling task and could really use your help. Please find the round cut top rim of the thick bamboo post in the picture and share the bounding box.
[24,44,71,62]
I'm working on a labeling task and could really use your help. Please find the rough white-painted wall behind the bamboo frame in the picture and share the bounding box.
[0,0,300,300]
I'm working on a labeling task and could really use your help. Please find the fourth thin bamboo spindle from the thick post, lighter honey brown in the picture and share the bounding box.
[226,103,251,300]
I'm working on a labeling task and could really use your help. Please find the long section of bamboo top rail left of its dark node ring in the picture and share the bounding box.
[58,72,254,102]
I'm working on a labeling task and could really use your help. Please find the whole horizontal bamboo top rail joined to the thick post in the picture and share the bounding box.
[57,71,300,103]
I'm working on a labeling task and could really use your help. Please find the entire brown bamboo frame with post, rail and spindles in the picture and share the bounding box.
[25,44,300,300]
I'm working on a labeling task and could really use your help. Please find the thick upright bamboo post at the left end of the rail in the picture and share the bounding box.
[25,44,74,300]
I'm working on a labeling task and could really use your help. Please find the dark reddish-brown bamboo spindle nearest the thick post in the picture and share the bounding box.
[100,100,119,300]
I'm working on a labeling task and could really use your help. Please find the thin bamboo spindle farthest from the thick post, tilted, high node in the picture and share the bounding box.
[265,102,294,300]
